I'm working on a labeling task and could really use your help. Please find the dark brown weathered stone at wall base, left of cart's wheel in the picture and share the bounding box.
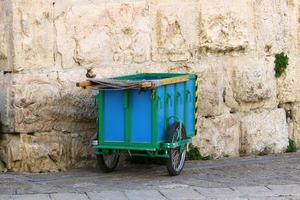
[0,132,95,172]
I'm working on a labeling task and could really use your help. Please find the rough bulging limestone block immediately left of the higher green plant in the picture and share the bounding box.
[224,58,278,111]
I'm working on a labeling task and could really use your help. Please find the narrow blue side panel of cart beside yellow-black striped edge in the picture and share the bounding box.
[186,80,195,136]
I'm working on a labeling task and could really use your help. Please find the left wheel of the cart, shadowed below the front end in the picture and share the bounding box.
[97,150,120,173]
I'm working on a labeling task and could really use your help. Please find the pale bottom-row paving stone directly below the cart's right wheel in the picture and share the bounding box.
[160,188,205,200]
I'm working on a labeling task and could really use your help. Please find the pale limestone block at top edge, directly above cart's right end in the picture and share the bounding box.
[150,0,199,61]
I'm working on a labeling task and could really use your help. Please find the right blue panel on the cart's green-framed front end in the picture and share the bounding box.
[130,90,152,143]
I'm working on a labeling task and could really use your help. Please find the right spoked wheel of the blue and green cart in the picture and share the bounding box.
[166,122,187,176]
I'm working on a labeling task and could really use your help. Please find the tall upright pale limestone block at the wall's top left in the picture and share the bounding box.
[11,0,55,71]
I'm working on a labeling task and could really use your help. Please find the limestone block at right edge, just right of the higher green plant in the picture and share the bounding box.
[278,54,300,104]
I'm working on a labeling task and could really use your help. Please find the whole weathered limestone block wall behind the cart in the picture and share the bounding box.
[0,0,300,172]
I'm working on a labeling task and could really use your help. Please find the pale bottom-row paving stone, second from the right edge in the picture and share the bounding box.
[233,186,276,197]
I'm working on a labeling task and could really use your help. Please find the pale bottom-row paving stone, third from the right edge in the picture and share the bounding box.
[196,187,237,198]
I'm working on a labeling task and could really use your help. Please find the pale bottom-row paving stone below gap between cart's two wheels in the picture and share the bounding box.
[125,190,166,200]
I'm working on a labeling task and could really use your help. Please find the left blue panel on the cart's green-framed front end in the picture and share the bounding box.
[104,91,125,142]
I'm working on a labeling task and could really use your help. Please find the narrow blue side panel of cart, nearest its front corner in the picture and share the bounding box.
[156,87,165,141]
